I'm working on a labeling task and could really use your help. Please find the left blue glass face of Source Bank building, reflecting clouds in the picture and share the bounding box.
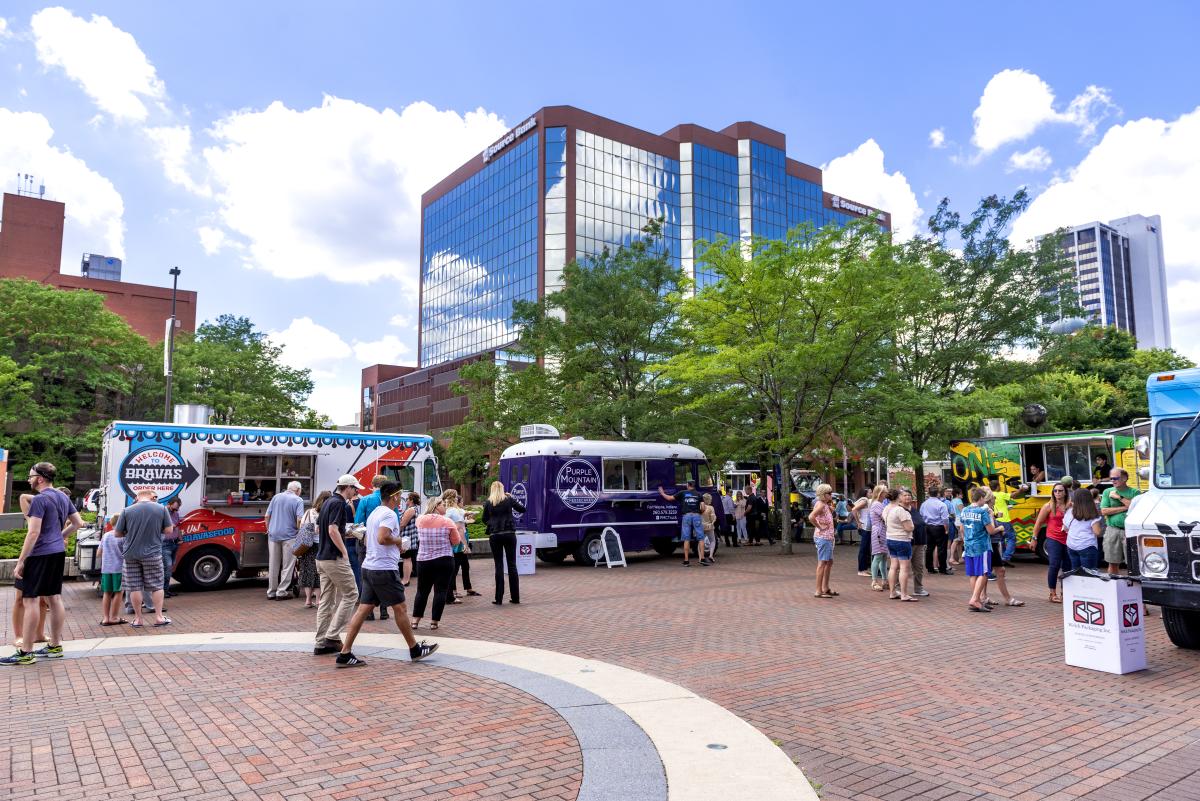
[420,134,539,366]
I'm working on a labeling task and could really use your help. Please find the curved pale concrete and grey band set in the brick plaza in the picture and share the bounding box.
[64,632,817,801]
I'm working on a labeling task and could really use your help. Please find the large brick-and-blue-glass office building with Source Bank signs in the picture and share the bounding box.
[361,106,892,433]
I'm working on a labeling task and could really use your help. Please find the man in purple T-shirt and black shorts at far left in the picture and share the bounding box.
[0,462,83,666]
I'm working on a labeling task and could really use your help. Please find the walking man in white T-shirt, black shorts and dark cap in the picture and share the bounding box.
[337,481,438,668]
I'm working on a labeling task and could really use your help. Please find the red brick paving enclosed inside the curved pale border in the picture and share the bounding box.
[0,652,582,801]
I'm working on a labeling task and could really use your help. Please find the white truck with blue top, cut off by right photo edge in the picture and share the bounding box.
[1126,368,1200,649]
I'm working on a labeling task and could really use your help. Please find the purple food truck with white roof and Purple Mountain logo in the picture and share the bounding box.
[500,424,721,566]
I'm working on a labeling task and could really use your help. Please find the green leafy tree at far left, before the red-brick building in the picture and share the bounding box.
[0,279,149,484]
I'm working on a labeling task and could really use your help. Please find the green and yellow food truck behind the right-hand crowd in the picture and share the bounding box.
[950,427,1144,560]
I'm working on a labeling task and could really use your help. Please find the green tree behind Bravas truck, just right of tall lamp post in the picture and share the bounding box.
[174,314,329,428]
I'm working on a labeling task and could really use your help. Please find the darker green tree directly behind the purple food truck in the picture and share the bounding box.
[512,221,684,440]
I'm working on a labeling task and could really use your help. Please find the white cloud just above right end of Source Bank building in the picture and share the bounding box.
[821,139,922,240]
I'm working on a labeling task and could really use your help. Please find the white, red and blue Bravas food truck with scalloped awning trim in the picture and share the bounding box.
[98,421,442,590]
